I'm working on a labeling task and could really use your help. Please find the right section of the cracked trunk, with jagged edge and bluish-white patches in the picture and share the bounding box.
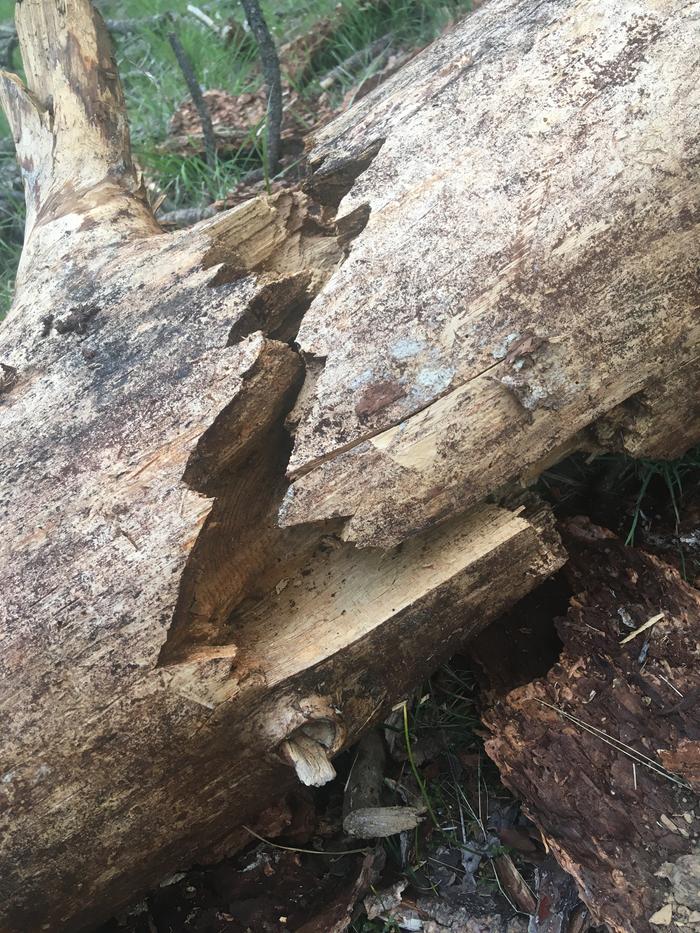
[282,0,700,545]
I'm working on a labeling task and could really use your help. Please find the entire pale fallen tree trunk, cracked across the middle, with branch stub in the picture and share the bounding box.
[0,0,700,931]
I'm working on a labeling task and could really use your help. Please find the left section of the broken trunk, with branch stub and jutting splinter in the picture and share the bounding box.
[0,0,562,933]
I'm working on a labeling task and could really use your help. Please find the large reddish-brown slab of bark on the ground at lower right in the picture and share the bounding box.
[485,520,700,933]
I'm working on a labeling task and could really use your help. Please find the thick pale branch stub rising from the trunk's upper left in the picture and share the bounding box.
[0,0,153,238]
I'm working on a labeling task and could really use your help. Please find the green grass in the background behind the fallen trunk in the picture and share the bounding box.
[0,0,470,318]
